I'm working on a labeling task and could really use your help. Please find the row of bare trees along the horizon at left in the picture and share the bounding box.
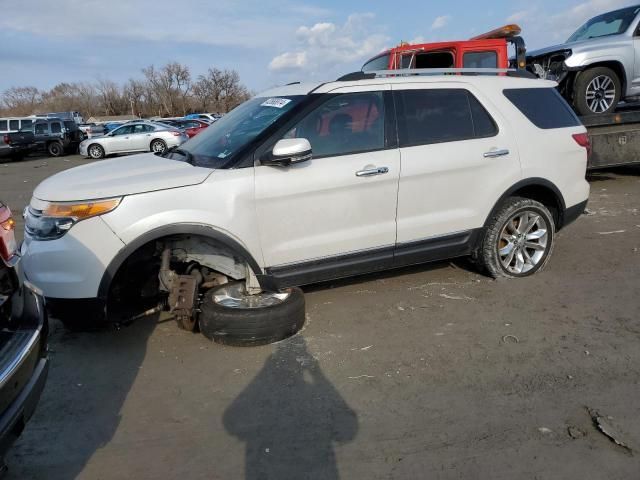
[0,62,251,119]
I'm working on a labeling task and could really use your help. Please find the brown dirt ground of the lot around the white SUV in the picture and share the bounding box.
[0,157,640,480]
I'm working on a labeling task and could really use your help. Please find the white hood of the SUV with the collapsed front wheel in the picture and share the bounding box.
[33,153,213,202]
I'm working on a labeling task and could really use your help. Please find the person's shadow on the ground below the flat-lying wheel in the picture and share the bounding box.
[223,337,358,480]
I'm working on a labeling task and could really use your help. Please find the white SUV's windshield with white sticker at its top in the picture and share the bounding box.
[168,95,304,168]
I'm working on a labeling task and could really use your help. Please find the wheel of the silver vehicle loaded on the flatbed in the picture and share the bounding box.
[574,67,622,115]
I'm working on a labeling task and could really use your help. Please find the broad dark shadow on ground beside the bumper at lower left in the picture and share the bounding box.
[3,306,158,480]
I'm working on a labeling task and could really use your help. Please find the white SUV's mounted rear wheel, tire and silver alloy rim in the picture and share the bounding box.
[476,197,555,277]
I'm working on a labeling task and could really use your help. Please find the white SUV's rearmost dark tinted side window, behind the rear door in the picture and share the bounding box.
[503,88,581,130]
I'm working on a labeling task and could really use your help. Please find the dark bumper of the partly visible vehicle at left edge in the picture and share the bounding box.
[0,287,49,459]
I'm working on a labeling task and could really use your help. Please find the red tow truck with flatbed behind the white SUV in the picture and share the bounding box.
[362,25,640,170]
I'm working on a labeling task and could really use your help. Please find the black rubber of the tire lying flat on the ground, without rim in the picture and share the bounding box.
[199,285,305,347]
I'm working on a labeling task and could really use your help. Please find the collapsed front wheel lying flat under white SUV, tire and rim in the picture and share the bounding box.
[199,282,305,347]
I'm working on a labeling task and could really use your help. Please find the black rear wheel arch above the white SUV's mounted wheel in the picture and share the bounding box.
[483,178,566,230]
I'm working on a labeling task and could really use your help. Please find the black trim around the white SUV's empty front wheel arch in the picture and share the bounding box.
[98,223,272,301]
